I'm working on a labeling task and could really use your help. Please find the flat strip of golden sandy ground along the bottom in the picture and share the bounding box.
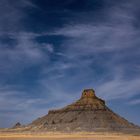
[0,133,140,140]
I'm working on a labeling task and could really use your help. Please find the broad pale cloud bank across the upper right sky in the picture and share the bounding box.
[49,24,140,55]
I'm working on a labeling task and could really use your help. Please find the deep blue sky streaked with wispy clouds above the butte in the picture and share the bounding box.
[0,0,140,127]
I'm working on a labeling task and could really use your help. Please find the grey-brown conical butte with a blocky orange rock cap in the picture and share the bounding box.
[29,89,138,131]
